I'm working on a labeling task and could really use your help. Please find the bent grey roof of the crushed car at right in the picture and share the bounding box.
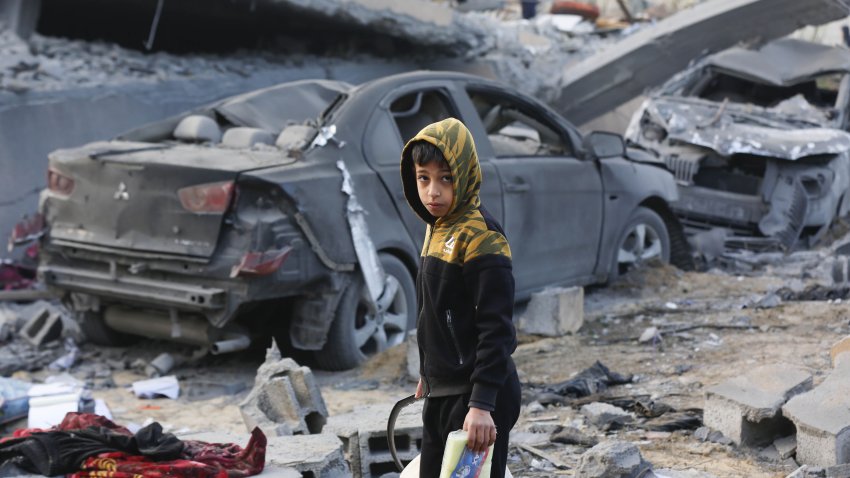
[706,38,850,86]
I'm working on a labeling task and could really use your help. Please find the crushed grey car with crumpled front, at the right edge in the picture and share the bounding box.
[625,39,850,250]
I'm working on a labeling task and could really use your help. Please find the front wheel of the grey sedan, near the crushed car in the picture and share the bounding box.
[608,207,670,281]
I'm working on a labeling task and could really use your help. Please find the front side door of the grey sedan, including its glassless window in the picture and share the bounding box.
[460,84,603,292]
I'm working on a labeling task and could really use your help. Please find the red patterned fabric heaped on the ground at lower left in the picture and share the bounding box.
[69,428,266,478]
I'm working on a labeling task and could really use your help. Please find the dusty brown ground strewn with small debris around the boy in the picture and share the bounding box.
[6,248,850,477]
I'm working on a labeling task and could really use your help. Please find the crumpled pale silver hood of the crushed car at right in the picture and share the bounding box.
[626,96,850,161]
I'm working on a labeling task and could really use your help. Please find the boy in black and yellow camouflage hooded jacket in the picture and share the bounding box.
[401,118,520,478]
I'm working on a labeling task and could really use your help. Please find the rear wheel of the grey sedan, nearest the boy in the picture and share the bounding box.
[315,254,416,370]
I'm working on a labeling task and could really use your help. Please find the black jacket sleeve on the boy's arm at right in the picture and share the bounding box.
[463,254,517,411]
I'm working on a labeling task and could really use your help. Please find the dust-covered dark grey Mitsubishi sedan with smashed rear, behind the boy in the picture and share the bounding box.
[39,72,690,369]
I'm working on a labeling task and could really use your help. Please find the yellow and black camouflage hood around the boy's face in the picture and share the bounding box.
[401,118,481,225]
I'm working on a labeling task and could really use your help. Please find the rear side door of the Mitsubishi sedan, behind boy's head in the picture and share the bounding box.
[364,81,502,244]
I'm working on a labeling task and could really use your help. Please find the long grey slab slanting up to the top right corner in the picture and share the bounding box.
[552,0,850,124]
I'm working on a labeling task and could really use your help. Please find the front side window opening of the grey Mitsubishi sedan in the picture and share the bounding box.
[467,89,572,158]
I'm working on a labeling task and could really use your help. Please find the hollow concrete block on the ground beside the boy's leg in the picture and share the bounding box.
[325,400,424,477]
